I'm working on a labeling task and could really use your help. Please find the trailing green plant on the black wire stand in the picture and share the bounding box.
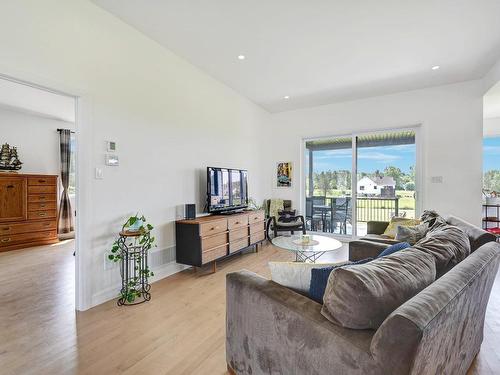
[108,214,157,303]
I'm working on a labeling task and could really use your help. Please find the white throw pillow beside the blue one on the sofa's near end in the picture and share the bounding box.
[269,262,350,295]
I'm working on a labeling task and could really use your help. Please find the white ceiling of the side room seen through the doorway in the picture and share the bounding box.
[0,78,75,122]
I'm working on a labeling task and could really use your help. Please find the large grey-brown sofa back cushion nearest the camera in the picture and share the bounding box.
[321,248,436,329]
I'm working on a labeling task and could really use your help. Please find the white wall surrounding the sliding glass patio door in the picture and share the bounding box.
[267,81,483,225]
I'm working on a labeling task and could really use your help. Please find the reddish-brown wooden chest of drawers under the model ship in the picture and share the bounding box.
[0,173,58,251]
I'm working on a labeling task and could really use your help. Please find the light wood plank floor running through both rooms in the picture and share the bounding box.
[0,241,500,375]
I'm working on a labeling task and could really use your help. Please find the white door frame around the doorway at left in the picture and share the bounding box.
[0,70,93,311]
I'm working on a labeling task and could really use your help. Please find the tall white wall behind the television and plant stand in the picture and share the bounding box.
[0,0,269,307]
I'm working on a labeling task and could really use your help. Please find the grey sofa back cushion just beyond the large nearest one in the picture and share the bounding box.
[413,224,470,277]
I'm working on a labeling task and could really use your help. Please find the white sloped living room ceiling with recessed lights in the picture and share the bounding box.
[93,0,500,112]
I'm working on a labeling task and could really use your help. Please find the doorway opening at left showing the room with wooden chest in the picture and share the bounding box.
[0,75,79,312]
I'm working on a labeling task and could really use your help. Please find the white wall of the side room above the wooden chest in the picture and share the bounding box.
[0,106,75,175]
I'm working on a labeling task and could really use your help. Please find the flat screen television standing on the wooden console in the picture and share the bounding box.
[207,167,248,213]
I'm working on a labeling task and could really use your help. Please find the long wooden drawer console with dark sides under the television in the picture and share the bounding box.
[175,210,266,272]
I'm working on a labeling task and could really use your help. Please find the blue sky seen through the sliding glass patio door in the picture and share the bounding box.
[314,143,418,173]
